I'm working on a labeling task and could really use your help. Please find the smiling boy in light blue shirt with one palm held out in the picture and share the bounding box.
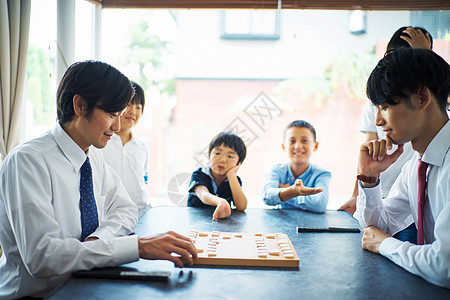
[262,120,331,213]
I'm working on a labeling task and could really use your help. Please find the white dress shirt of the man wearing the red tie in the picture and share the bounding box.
[356,121,450,288]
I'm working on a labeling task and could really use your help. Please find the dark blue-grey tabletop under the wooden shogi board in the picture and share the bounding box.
[50,207,450,300]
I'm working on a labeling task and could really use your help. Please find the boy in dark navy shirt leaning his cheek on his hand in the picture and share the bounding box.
[187,132,247,220]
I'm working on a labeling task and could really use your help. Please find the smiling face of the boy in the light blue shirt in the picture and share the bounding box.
[282,127,319,164]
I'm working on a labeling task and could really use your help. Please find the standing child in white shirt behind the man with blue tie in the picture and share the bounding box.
[102,81,151,216]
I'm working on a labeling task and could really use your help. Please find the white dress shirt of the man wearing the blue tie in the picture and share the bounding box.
[0,124,139,299]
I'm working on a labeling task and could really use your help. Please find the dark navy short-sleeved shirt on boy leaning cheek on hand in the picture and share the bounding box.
[187,168,242,207]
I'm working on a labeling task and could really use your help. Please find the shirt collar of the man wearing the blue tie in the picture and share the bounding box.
[52,122,89,171]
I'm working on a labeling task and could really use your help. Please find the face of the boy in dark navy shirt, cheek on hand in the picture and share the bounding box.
[209,144,239,176]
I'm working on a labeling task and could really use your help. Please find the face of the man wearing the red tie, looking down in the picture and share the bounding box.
[375,94,421,144]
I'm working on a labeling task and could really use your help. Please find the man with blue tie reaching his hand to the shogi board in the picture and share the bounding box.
[0,61,196,299]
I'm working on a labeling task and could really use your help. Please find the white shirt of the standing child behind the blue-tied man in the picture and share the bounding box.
[101,134,151,216]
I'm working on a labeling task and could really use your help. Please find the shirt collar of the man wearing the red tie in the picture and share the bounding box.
[422,120,450,167]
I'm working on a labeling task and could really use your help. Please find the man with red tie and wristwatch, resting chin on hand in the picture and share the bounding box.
[356,48,450,288]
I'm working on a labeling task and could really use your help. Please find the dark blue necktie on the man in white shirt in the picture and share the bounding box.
[80,157,98,241]
